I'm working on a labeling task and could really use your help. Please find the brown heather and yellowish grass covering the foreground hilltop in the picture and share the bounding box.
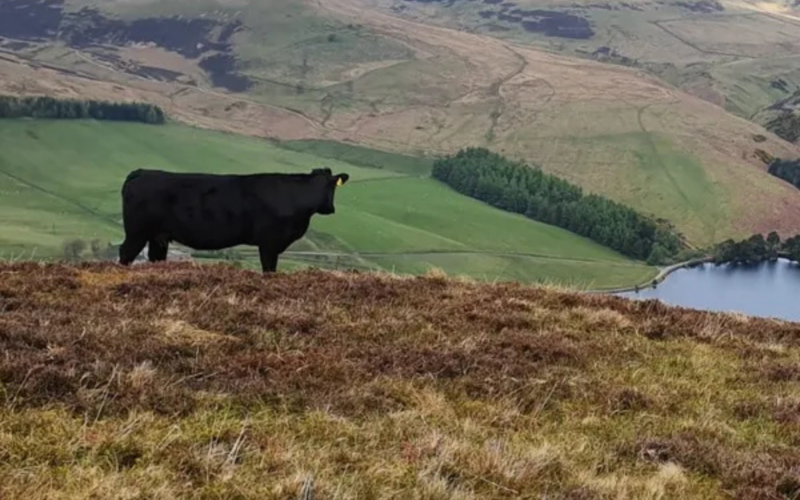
[0,263,800,500]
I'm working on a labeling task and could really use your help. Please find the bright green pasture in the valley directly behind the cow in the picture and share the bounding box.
[0,121,655,287]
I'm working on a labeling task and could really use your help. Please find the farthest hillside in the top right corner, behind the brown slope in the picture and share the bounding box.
[362,0,800,131]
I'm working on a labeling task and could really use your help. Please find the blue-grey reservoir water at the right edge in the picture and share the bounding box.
[617,259,800,321]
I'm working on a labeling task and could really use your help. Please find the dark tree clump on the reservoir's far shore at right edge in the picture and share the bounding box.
[713,231,800,265]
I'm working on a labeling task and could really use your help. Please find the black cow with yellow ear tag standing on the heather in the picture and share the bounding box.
[119,168,350,273]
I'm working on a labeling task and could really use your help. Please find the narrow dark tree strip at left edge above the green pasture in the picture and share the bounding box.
[0,96,166,125]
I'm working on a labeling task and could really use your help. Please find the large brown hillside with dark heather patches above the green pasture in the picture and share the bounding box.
[0,0,800,244]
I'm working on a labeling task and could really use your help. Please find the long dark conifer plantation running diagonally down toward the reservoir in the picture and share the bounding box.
[432,148,683,264]
